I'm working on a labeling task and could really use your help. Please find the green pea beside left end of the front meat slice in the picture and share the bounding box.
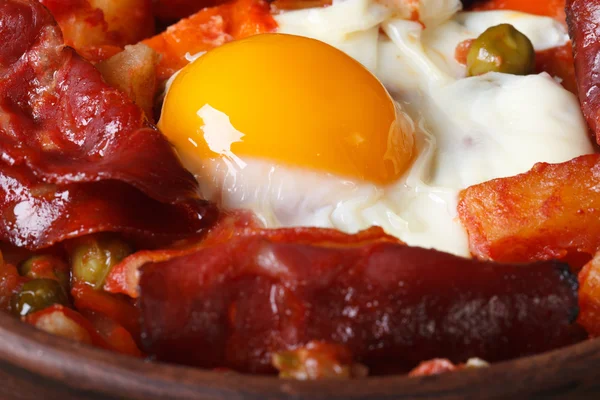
[71,235,132,289]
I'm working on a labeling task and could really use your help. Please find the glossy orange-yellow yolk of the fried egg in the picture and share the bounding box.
[158,34,414,184]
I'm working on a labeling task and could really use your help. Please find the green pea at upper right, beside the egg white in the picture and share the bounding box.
[467,24,535,76]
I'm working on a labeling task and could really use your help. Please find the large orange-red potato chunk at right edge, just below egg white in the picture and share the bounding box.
[458,154,600,262]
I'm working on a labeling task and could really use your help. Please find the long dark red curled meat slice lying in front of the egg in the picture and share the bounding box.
[138,214,583,373]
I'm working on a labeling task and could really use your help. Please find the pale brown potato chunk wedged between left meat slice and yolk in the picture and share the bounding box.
[96,43,159,119]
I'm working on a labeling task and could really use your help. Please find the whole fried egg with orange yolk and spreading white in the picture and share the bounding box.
[158,0,593,256]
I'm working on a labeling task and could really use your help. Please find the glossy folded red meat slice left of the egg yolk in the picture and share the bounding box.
[0,0,216,249]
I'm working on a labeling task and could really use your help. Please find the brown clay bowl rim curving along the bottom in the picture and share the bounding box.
[0,313,600,400]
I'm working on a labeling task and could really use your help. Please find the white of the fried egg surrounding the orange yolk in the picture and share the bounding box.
[159,0,593,256]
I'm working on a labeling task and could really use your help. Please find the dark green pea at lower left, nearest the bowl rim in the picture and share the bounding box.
[11,279,69,317]
